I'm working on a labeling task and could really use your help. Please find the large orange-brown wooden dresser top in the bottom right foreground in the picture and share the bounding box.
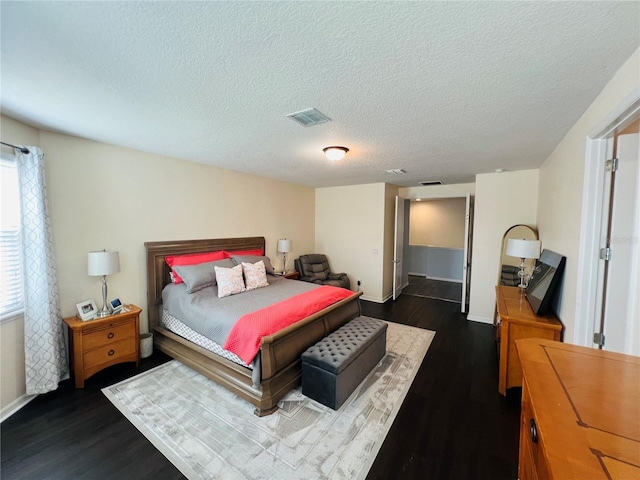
[516,338,640,480]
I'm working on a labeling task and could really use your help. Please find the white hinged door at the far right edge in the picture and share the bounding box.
[594,133,640,355]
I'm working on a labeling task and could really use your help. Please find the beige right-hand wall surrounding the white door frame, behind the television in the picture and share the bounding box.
[538,49,640,343]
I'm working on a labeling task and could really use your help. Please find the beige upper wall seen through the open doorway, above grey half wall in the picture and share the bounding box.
[409,198,466,248]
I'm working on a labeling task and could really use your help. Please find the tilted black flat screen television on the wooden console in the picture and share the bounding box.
[525,249,566,315]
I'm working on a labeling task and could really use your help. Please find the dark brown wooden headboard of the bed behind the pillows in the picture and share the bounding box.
[144,237,265,331]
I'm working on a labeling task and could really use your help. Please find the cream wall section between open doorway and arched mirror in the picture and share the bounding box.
[467,170,538,323]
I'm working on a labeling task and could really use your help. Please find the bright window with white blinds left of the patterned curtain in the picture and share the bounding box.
[0,152,23,321]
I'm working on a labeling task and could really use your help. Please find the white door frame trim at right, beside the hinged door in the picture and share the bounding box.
[572,87,640,347]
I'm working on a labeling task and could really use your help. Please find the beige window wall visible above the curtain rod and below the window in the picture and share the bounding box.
[0,117,40,409]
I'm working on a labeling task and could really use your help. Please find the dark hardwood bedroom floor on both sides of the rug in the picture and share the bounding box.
[0,295,520,480]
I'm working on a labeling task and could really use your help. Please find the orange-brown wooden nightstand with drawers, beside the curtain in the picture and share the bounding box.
[63,305,142,388]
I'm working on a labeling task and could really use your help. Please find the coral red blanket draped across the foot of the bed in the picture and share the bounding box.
[224,285,353,364]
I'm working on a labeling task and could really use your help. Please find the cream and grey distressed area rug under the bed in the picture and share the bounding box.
[102,322,435,480]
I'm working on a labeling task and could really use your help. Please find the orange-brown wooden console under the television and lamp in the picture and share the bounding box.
[496,286,562,395]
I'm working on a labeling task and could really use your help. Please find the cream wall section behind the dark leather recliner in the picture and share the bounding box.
[314,183,388,302]
